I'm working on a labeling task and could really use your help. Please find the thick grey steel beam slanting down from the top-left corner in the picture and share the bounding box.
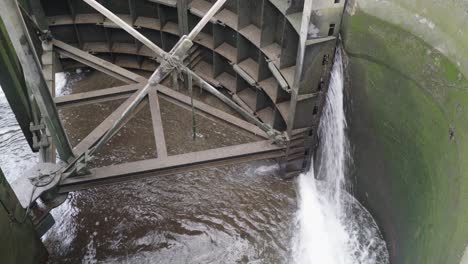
[0,0,74,161]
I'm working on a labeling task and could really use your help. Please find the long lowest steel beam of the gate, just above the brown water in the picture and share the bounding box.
[59,140,284,193]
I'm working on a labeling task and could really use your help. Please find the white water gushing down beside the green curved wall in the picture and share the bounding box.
[293,49,389,264]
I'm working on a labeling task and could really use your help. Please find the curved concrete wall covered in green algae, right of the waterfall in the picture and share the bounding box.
[342,0,468,264]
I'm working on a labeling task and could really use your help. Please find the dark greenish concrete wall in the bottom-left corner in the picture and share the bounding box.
[0,169,47,264]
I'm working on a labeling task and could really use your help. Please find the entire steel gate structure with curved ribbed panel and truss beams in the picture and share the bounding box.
[0,0,344,228]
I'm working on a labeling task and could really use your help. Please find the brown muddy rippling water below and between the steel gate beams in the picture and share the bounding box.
[43,72,296,263]
